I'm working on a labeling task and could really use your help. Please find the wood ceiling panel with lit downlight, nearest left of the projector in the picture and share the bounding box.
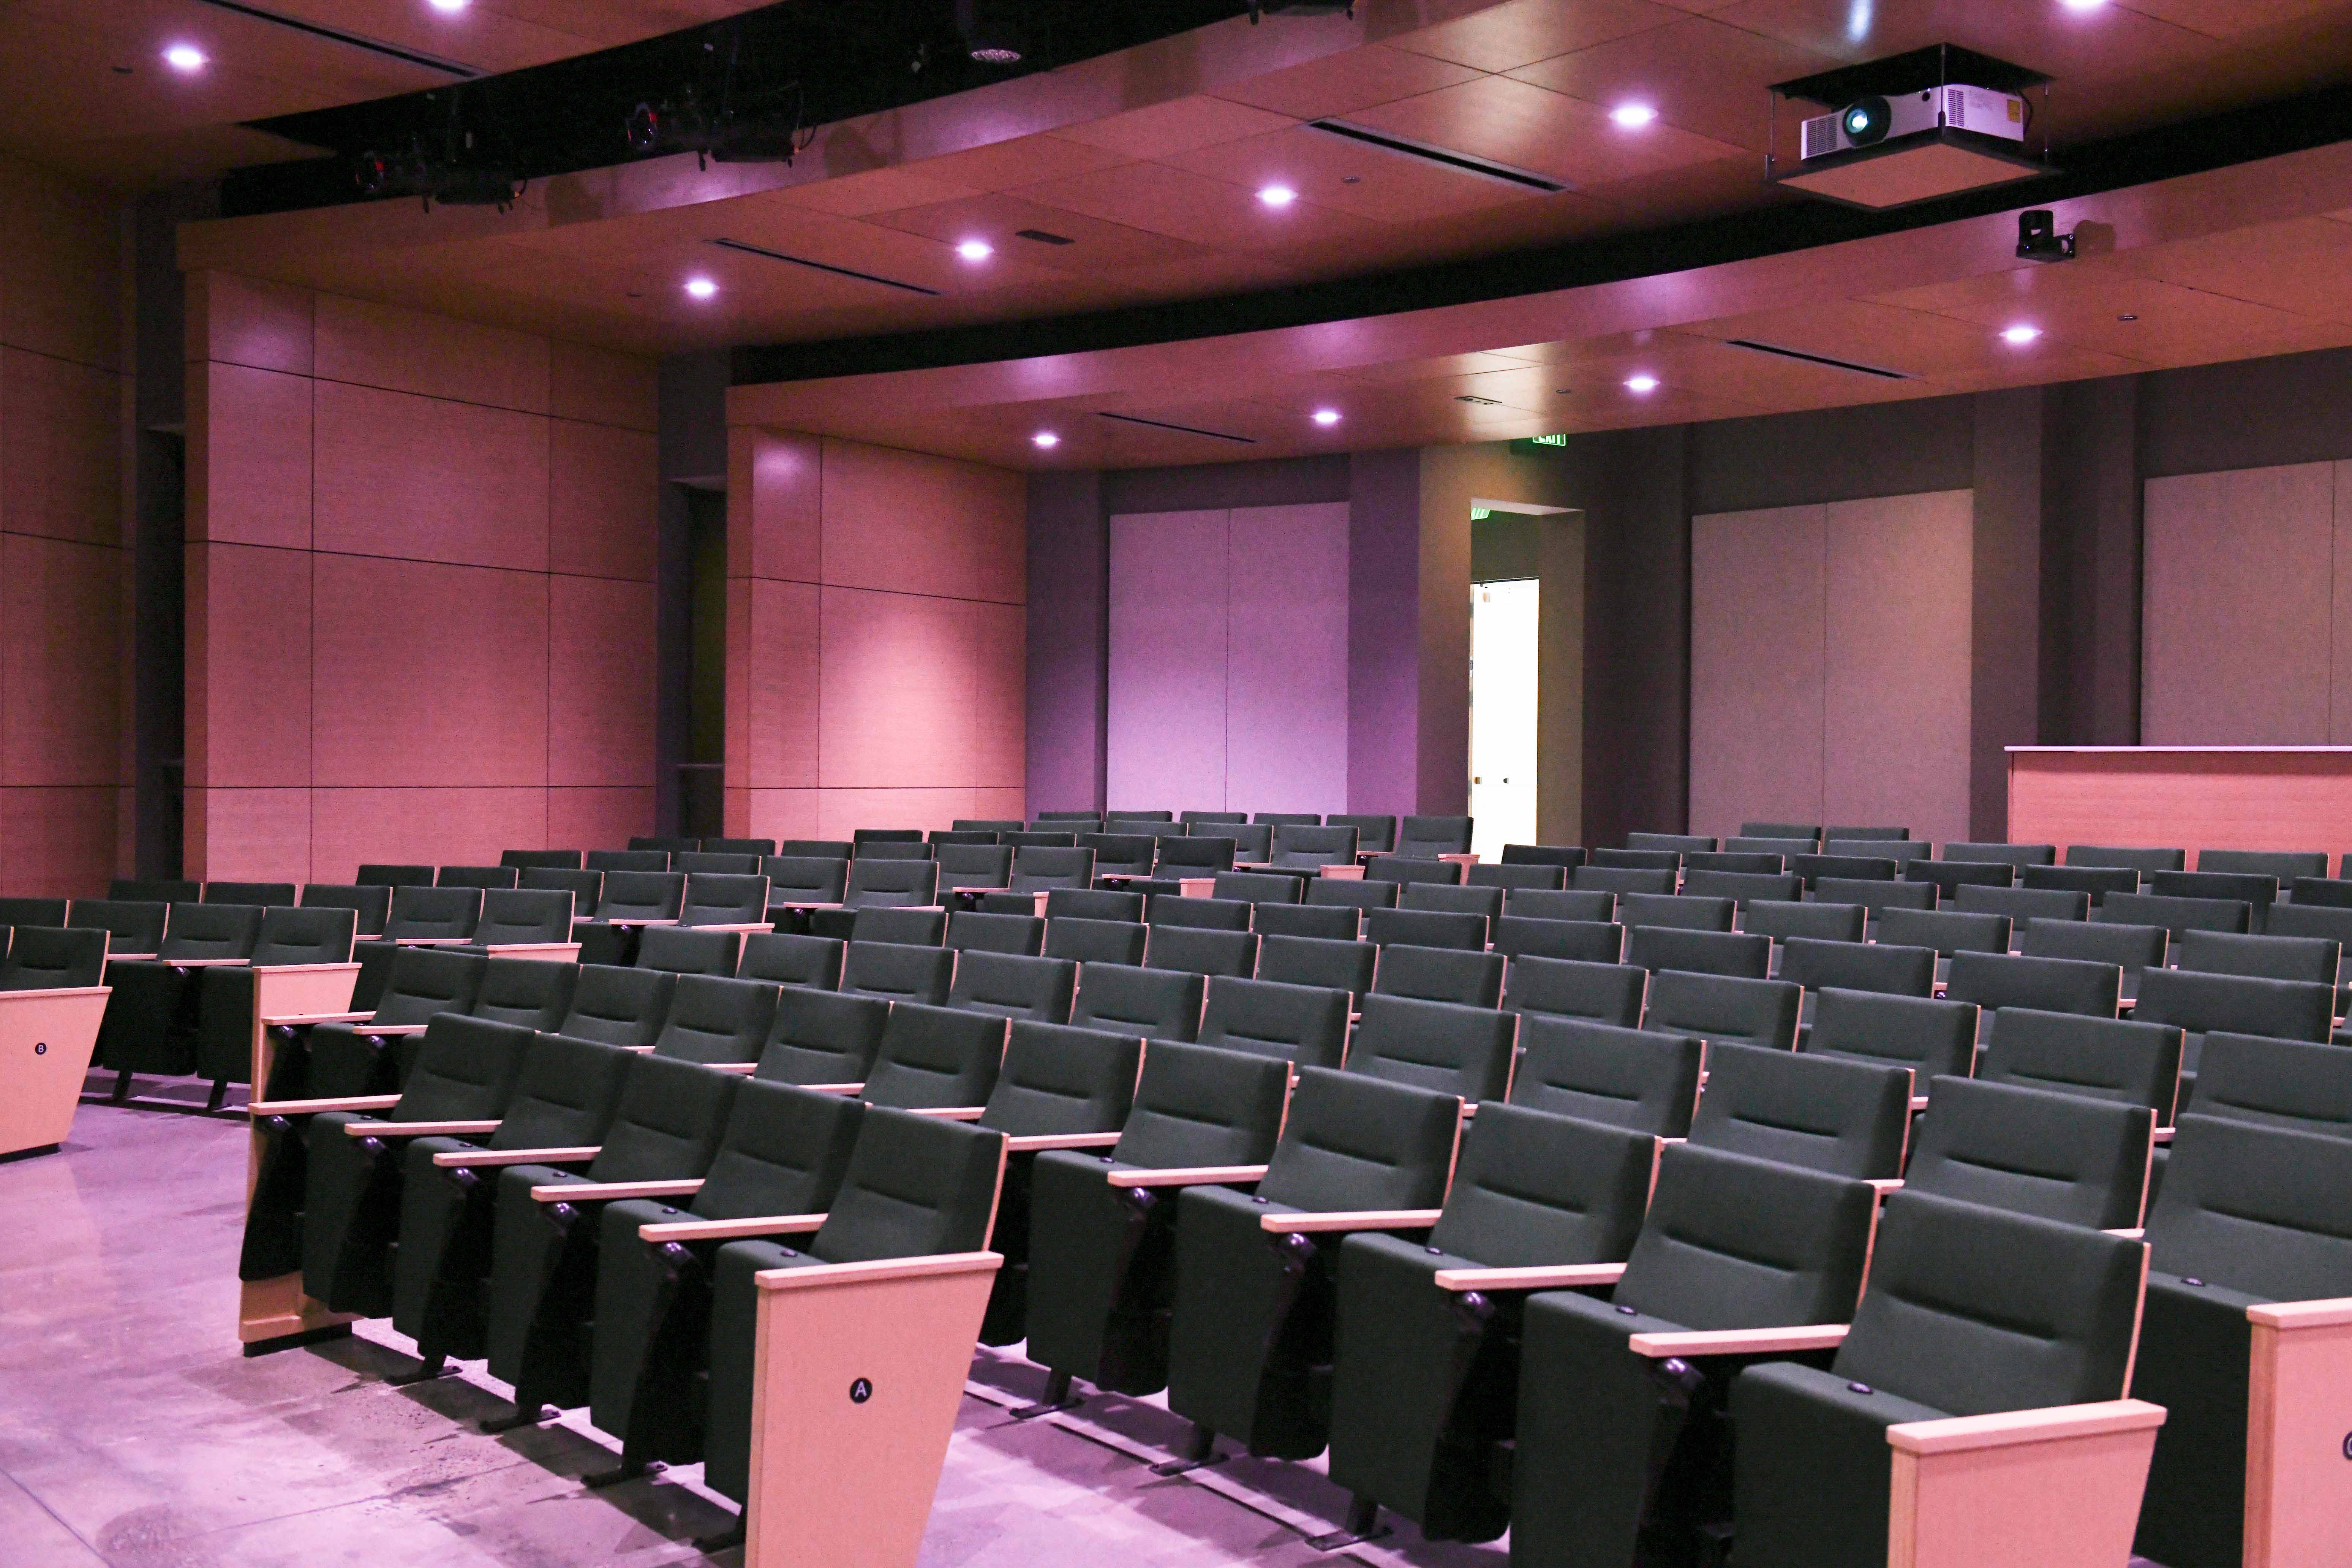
[1355,75,1743,186]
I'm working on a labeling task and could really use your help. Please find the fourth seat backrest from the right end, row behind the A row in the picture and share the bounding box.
[1258,1067,1461,1208]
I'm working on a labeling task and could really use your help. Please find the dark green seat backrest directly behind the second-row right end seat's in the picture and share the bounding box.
[1903,1077,2157,1230]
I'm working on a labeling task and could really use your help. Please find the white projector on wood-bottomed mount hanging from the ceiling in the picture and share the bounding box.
[1773,45,2053,207]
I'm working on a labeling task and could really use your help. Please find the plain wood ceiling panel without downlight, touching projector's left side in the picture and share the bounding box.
[1510,16,1835,153]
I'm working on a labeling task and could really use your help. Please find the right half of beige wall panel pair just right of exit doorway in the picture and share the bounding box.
[1823,489,1973,844]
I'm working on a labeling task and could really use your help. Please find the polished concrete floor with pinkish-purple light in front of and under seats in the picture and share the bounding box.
[0,1100,1505,1568]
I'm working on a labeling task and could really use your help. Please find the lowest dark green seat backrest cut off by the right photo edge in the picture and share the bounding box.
[2147,1114,2352,1302]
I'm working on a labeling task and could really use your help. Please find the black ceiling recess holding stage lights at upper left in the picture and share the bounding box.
[221,0,1270,216]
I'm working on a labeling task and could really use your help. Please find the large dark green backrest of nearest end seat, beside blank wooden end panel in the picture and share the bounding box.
[1832,1187,2147,1415]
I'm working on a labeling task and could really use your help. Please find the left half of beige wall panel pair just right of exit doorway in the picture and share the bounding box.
[1691,506,1827,837]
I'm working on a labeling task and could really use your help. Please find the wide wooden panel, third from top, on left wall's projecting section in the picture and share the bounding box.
[310,555,548,790]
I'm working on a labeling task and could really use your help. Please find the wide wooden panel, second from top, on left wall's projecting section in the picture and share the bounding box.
[313,381,550,571]
